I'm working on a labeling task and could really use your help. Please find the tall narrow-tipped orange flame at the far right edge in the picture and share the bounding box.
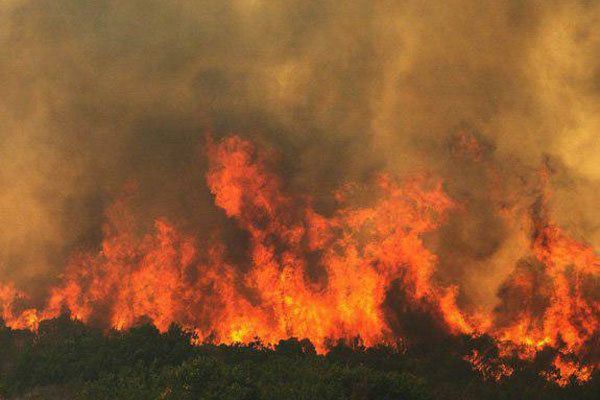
[494,166,600,385]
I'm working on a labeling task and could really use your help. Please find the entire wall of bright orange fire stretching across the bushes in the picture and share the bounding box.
[0,136,600,384]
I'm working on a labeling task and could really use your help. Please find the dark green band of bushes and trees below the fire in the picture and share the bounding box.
[0,316,600,400]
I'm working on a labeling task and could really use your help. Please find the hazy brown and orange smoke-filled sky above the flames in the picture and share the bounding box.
[0,0,600,307]
